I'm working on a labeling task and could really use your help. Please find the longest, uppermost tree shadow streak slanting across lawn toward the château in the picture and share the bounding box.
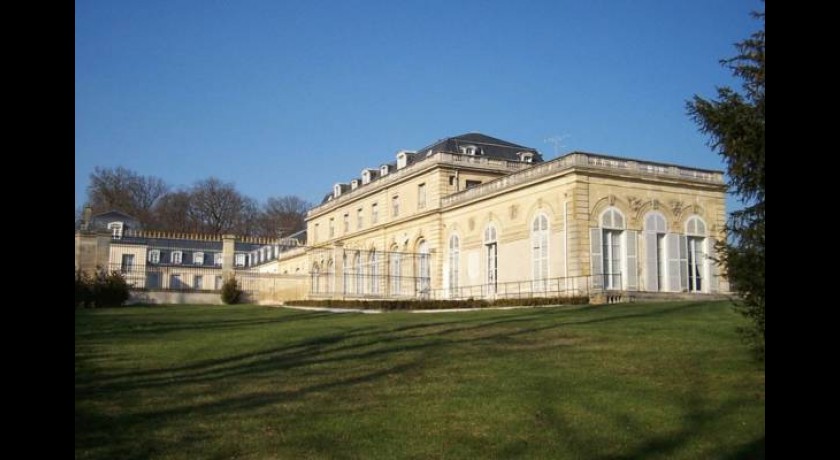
[76,304,716,397]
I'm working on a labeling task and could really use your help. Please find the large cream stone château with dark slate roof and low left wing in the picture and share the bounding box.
[77,133,728,303]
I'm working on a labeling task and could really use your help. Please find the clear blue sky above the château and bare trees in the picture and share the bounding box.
[75,0,763,209]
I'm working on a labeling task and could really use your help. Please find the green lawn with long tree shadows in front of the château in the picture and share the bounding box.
[75,302,764,459]
